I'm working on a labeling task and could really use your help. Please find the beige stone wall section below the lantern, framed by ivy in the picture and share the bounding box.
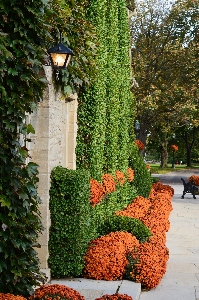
[27,66,77,279]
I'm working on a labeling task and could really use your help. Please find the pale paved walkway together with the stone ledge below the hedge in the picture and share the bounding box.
[51,169,199,300]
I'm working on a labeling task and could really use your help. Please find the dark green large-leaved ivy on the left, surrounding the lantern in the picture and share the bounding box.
[0,0,96,296]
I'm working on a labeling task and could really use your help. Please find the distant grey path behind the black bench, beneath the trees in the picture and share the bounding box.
[152,169,199,185]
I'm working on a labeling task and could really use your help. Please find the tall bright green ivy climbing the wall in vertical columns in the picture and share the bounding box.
[76,0,135,181]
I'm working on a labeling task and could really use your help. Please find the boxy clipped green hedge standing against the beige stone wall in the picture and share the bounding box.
[49,167,96,278]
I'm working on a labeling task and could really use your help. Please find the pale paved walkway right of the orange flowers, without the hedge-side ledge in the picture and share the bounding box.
[139,169,199,300]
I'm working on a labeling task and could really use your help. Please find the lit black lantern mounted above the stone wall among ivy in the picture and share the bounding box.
[47,32,74,80]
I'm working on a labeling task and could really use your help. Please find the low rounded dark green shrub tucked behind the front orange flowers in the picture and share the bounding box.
[97,215,152,243]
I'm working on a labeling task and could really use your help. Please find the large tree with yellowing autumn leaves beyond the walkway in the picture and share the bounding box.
[132,1,198,166]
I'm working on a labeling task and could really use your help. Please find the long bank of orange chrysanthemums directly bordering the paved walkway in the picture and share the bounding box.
[112,182,174,289]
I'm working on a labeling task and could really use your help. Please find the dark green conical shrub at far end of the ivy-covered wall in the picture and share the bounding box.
[129,146,152,198]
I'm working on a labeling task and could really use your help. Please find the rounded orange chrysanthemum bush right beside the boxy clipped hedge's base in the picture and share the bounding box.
[83,232,139,280]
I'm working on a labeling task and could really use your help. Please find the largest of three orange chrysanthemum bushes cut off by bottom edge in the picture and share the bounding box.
[29,284,85,300]
